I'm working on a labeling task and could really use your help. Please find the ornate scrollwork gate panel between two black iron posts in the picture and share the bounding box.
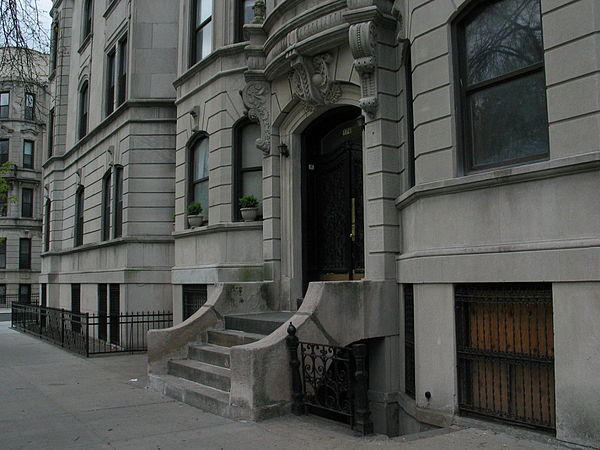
[300,342,355,426]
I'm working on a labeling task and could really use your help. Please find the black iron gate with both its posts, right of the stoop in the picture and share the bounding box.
[287,323,373,434]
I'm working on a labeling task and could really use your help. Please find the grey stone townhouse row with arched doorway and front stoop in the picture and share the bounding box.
[42,0,600,445]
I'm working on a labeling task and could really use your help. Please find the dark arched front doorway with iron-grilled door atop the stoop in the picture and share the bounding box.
[302,106,365,290]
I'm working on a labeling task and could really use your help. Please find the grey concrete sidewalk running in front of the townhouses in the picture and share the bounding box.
[0,322,572,450]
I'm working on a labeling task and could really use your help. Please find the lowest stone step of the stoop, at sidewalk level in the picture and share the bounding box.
[150,375,230,417]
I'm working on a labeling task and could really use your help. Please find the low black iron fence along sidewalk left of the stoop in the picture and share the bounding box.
[12,303,173,356]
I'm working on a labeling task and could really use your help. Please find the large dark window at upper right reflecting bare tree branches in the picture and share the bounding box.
[457,0,548,171]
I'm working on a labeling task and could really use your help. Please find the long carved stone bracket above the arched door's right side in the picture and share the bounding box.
[350,22,379,117]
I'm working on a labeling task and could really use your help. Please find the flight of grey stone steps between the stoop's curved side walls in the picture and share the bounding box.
[155,311,294,418]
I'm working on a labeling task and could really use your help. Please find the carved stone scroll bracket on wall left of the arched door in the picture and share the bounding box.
[242,81,271,155]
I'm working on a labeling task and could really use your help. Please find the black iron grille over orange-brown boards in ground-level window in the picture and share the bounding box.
[455,283,556,430]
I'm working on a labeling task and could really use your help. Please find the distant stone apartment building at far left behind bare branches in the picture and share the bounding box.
[0,48,48,304]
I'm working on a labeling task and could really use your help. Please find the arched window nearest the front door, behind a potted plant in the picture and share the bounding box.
[233,123,262,220]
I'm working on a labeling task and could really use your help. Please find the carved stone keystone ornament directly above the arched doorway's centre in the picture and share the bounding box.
[290,53,342,112]
